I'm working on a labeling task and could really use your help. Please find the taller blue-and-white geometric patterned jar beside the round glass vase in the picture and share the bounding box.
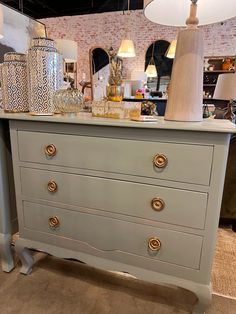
[27,37,63,115]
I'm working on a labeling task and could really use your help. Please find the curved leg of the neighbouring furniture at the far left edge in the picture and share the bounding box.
[0,233,14,273]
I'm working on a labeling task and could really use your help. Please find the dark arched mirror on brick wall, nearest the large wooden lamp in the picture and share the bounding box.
[145,40,173,96]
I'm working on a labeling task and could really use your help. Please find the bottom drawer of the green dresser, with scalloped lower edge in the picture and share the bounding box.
[23,202,202,269]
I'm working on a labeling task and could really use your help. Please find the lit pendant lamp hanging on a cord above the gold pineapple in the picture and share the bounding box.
[117,0,136,58]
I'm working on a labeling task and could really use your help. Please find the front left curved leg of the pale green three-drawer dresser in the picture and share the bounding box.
[16,239,34,275]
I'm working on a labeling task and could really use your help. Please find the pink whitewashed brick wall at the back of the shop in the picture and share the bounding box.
[41,10,236,86]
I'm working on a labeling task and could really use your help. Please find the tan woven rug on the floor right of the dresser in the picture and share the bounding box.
[212,228,236,298]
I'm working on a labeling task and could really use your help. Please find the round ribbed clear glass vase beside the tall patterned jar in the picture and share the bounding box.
[53,88,84,115]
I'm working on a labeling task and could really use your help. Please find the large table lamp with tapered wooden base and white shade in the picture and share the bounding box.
[144,0,236,121]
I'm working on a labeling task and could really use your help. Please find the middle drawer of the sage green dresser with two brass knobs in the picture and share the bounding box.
[21,168,207,229]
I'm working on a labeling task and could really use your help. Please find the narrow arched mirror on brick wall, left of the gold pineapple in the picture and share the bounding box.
[90,47,109,100]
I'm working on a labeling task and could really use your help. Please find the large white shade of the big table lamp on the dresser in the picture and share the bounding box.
[144,0,236,26]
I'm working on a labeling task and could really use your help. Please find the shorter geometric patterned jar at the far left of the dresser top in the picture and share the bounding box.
[0,52,29,112]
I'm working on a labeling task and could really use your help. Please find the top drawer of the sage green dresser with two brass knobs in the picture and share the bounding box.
[18,131,213,185]
